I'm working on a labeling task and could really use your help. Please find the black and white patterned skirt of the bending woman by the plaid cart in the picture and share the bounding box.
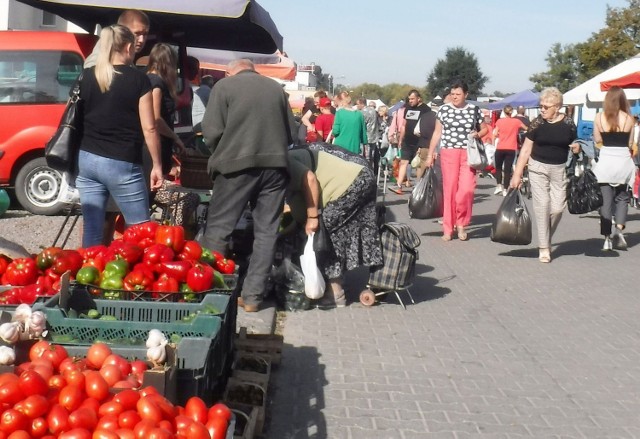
[322,167,382,279]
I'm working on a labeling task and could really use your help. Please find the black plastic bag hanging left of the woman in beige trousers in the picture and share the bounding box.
[491,189,531,245]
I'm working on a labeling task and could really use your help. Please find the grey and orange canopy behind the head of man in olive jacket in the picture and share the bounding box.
[187,47,297,81]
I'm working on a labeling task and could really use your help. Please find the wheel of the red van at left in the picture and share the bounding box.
[15,157,65,215]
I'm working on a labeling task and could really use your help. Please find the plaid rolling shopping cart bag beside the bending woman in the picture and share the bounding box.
[369,222,420,290]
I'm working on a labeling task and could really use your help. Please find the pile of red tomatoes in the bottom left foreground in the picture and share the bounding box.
[0,340,232,439]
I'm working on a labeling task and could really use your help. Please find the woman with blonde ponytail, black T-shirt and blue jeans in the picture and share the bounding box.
[76,25,163,247]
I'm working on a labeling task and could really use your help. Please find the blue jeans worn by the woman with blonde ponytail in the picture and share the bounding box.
[76,151,149,247]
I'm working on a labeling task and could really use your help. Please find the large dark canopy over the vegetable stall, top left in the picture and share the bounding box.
[18,0,282,54]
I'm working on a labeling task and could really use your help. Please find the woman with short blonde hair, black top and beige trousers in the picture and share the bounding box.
[509,87,580,263]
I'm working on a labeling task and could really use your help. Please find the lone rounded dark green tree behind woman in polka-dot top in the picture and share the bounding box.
[426,47,489,99]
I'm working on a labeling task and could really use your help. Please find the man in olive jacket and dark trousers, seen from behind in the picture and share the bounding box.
[202,59,293,312]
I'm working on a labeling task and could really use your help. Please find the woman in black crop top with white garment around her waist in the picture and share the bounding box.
[593,87,635,250]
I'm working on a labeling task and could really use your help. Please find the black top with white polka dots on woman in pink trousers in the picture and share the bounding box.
[437,104,482,149]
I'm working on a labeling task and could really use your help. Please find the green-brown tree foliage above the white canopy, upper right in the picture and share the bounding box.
[529,0,640,92]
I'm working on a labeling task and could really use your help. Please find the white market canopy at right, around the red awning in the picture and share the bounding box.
[563,55,640,108]
